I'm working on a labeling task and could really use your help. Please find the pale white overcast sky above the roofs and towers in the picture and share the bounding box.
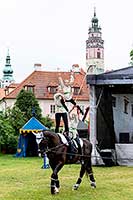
[0,0,133,82]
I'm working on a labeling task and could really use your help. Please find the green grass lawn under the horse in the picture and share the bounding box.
[0,155,133,200]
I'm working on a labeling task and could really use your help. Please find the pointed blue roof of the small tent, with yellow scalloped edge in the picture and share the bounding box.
[20,117,48,133]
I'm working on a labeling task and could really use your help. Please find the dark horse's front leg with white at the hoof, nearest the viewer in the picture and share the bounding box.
[51,162,64,194]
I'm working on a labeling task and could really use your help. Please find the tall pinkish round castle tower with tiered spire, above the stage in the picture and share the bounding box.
[86,9,104,74]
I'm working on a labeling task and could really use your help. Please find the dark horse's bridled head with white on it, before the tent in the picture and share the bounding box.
[34,132,48,157]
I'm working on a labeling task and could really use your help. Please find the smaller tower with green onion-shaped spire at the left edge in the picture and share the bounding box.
[1,50,14,88]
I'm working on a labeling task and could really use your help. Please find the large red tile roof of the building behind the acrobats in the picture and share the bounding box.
[6,69,89,100]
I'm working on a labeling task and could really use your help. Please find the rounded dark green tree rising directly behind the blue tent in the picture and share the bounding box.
[15,89,42,121]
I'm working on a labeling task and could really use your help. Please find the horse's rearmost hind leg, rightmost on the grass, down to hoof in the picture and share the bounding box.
[86,158,96,188]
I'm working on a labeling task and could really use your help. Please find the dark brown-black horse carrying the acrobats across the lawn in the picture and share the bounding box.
[39,131,96,194]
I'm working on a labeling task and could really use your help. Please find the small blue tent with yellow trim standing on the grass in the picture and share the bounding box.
[16,117,48,157]
